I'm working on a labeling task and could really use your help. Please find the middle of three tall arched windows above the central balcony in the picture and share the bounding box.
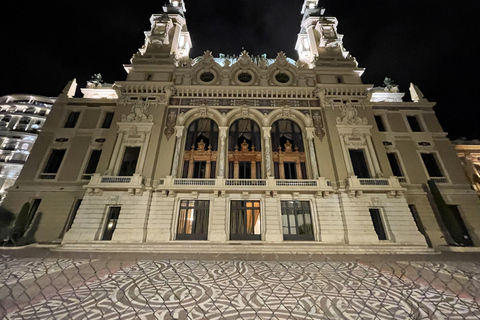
[228,119,262,179]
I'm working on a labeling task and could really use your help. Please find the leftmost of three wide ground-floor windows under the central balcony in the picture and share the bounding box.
[177,200,210,240]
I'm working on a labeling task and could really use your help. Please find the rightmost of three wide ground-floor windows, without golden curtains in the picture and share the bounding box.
[282,201,314,241]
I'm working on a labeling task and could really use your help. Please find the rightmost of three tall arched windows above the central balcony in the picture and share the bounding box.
[271,120,307,179]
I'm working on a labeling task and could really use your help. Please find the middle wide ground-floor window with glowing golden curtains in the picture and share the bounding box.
[230,200,261,240]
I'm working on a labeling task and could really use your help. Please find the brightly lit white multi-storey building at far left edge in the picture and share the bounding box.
[0,94,55,203]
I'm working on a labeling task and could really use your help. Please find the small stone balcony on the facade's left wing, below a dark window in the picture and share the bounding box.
[84,173,145,195]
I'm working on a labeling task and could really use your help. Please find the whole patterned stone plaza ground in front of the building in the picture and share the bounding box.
[0,250,480,319]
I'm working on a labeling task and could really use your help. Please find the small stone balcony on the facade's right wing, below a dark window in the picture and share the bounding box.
[347,176,404,196]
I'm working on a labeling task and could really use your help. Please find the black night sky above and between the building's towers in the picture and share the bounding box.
[0,0,480,138]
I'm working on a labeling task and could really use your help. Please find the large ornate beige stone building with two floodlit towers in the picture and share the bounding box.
[4,0,480,253]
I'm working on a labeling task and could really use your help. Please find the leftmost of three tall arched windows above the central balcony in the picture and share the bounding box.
[183,119,218,178]
